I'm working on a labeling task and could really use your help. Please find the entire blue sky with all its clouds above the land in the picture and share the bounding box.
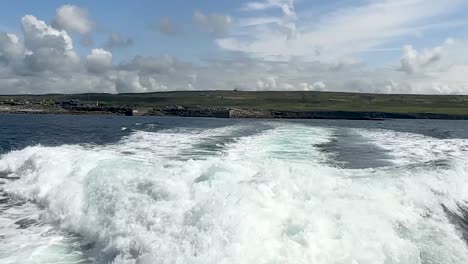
[0,0,468,94]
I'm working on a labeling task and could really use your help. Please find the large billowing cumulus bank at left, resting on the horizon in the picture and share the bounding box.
[0,15,196,94]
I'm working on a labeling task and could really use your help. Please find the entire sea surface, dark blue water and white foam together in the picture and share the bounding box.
[0,115,468,264]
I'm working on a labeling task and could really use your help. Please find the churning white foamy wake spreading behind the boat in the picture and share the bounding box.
[0,124,468,264]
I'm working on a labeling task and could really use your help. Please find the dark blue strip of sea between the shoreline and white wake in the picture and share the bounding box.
[0,115,468,153]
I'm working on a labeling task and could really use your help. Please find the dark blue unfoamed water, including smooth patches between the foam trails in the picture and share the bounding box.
[0,115,468,168]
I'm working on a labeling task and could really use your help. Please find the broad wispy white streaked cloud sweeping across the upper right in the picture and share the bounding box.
[217,0,468,62]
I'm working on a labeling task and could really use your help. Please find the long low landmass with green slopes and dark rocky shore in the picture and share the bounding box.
[0,91,468,120]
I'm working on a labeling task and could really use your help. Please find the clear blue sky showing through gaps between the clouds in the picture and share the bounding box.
[0,0,468,65]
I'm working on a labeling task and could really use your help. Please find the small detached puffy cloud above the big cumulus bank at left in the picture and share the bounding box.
[53,5,94,35]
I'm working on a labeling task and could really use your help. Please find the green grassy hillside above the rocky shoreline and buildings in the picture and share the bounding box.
[0,91,468,115]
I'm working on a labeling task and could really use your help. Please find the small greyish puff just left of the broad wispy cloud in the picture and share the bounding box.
[192,11,233,37]
